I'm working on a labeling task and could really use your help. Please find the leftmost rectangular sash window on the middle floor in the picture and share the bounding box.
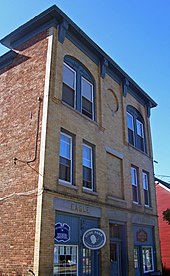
[59,132,73,184]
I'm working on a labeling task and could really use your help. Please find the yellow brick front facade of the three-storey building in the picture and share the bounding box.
[37,24,161,276]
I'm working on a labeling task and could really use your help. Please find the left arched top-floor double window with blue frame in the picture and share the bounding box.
[62,56,95,120]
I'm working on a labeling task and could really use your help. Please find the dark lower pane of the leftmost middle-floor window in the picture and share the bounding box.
[59,157,71,182]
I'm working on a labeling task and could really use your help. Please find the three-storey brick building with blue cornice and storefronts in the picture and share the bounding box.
[0,6,161,276]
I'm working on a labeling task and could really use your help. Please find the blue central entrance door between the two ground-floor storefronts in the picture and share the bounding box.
[110,241,122,276]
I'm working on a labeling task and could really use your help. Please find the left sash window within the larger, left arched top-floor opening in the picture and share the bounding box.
[62,63,76,108]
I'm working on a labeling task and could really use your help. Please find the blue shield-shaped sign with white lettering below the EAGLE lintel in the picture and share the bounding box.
[54,222,70,242]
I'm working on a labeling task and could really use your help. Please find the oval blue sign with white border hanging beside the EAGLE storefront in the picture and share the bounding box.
[83,228,106,250]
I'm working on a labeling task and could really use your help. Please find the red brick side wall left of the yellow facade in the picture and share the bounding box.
[0,32,47,276]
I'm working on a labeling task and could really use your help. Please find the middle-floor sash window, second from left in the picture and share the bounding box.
[82,144,94,190]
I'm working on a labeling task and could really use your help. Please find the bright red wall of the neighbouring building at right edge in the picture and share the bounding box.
[156,185,170,270]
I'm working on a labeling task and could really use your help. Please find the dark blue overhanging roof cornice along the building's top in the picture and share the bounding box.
[0,5,157,108]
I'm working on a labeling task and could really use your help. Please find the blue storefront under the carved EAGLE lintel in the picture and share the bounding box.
[53,199,101,276]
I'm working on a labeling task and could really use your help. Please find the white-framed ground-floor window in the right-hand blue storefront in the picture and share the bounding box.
[142,246,154,273]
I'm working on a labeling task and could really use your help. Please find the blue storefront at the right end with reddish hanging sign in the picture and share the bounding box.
[133,225,156,276]
